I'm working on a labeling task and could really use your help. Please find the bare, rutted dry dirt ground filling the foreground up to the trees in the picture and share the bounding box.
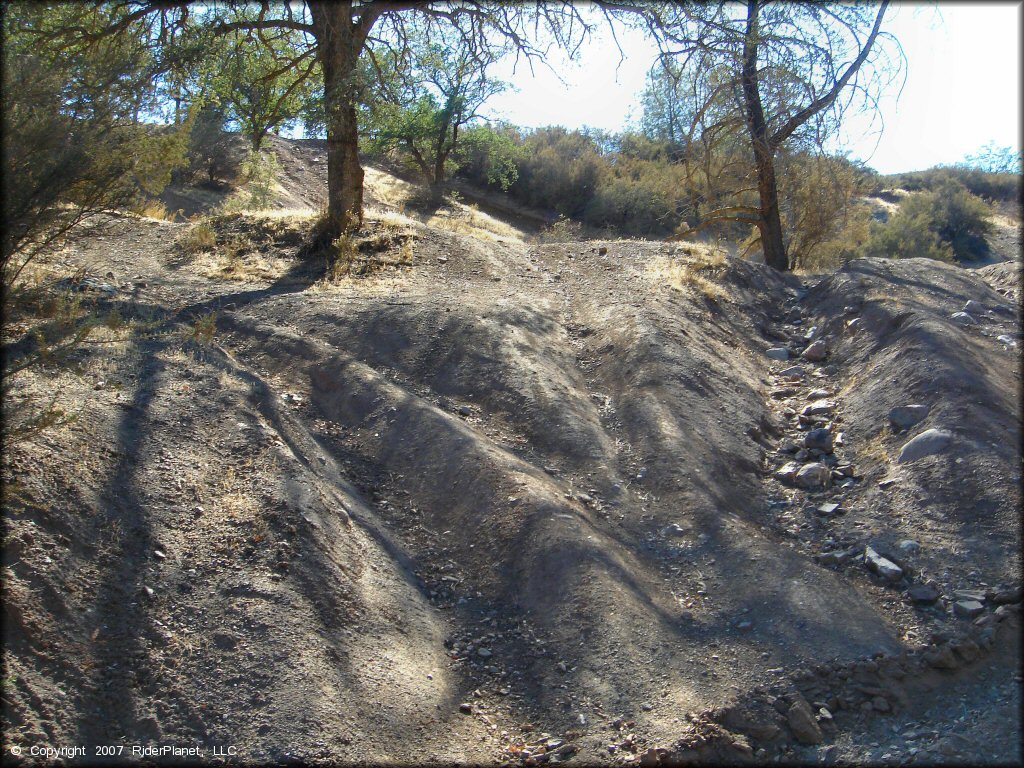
[3,141,1021,766]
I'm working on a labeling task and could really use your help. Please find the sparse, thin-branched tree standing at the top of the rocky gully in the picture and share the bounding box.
[641,0,902,270]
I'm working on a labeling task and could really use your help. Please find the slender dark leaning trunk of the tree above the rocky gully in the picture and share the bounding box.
[741,0,790,271]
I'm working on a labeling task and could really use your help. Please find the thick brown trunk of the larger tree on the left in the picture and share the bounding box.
[309,2,366,237]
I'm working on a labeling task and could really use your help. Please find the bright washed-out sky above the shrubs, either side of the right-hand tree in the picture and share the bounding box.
[485,3,1022,173]
